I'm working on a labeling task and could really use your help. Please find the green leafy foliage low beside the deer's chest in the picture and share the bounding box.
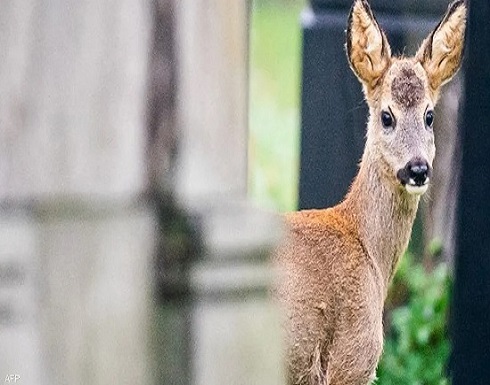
[376,253,451,385]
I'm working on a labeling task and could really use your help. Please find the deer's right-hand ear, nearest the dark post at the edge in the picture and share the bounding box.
[416,0,466,91]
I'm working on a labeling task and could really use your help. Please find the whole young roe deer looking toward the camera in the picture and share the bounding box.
[275,0,466,385]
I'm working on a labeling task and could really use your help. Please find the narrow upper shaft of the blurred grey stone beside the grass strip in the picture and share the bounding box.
[175,0,249,204]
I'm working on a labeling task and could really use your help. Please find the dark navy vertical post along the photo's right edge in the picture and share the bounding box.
[452,0,490,385]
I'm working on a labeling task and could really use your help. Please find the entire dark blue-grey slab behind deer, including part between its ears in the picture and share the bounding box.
[299,0,447,209]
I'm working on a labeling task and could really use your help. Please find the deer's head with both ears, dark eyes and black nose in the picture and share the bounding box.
[346,0,466,194]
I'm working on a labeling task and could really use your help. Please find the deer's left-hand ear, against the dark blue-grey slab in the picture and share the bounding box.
[346,0,391,90]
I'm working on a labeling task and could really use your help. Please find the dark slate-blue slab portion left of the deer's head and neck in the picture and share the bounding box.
[299,1,367,209]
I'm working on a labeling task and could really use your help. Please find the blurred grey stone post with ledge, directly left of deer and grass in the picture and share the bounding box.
[152,0,284,385]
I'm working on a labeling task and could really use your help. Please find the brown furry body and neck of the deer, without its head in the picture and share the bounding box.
[278,146,419,385]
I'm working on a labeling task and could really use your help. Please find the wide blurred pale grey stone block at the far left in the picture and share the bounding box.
[0,0,155,385]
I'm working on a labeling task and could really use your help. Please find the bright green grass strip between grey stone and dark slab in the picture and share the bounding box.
[248,0,304,211]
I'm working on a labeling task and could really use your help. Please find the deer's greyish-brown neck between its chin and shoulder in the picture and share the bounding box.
[340,149,420,291]
